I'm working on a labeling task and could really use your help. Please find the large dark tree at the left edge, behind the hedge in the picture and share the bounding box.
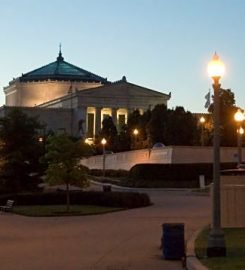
[0,108,43,192]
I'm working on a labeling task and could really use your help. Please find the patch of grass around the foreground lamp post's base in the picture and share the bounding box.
[195,228,245,270]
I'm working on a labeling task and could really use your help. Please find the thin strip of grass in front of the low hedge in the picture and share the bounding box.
[13,205,122,217]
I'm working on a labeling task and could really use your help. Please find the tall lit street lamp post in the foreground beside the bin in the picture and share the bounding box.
[207,53,226,257]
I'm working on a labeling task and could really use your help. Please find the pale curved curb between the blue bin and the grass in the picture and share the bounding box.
[186,229,209,270]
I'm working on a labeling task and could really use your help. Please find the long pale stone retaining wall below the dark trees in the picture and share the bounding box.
[81,146,245,170]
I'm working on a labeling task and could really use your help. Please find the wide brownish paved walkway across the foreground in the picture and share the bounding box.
[0,191,210,270]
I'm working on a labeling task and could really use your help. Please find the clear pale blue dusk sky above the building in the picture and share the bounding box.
[0,0,245,112]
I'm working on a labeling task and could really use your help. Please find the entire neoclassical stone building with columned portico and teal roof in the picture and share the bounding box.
[4,51,171,138]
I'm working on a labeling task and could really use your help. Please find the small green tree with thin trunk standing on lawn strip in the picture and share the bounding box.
[45,134,89,211]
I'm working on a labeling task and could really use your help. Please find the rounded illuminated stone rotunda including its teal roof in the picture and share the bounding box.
[4,51,109,107]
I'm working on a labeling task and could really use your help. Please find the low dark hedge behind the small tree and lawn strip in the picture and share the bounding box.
[0,191,151,208]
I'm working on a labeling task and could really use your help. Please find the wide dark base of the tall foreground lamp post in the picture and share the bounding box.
[207,231,226,257]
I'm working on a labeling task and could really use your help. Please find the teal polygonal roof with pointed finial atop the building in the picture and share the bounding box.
[19,50,108,84]
